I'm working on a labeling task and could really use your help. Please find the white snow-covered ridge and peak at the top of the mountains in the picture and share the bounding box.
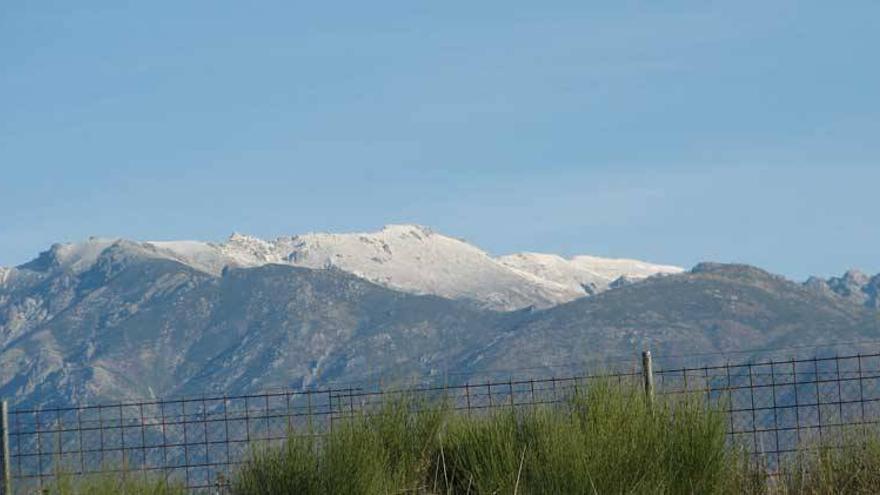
[1,225,682,310]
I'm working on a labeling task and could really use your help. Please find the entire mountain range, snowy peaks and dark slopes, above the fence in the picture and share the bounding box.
[0,225,880,405]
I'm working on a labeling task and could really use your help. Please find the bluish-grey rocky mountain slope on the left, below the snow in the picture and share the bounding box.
[0,245,510,404]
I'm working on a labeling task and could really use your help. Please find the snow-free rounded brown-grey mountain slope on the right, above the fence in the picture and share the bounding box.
[475,263,880,371]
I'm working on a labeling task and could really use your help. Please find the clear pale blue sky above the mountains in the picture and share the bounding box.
[0,0,880,278]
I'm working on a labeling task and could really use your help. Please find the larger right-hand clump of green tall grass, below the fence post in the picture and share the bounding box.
[439,383,747,494]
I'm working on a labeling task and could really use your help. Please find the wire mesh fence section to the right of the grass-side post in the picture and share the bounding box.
[657,354,880,470]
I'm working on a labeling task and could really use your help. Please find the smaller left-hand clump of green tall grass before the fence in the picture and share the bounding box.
[233,396,447,494]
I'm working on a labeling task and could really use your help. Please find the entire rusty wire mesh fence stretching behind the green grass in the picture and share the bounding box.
[5,353,880,494]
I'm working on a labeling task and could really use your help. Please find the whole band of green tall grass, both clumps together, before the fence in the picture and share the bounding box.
[233,383,760,495]
